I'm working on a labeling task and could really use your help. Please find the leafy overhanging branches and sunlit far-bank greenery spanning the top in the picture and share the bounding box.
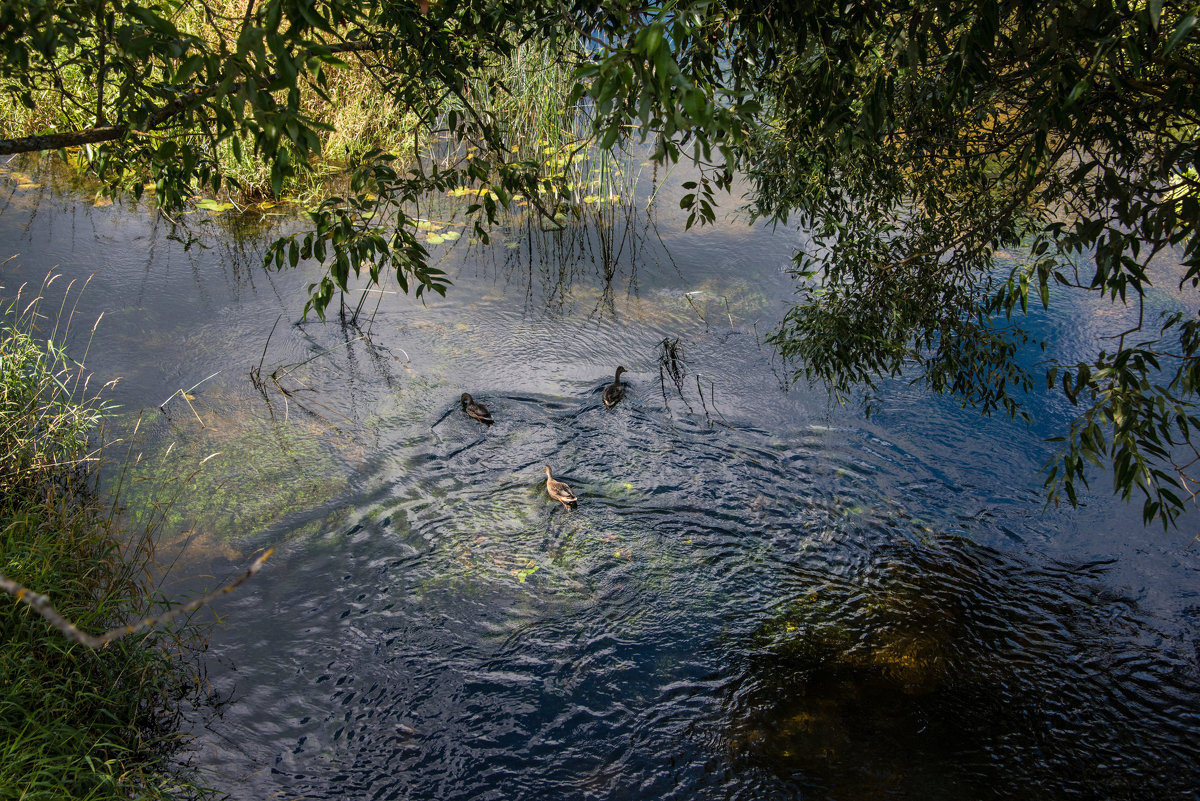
[0,0,1200,525]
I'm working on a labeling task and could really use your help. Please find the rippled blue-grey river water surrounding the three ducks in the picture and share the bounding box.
[0,159,1200,801]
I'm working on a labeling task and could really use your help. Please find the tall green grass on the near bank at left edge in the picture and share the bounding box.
[0,288,200,800]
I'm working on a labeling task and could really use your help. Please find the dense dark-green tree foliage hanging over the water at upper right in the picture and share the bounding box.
[742,0,1200,525]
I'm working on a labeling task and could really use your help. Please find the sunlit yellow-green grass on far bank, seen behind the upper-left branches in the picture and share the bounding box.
[0,0,586,205]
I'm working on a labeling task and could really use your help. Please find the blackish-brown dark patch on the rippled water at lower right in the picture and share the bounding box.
[728,538,1200,799]
